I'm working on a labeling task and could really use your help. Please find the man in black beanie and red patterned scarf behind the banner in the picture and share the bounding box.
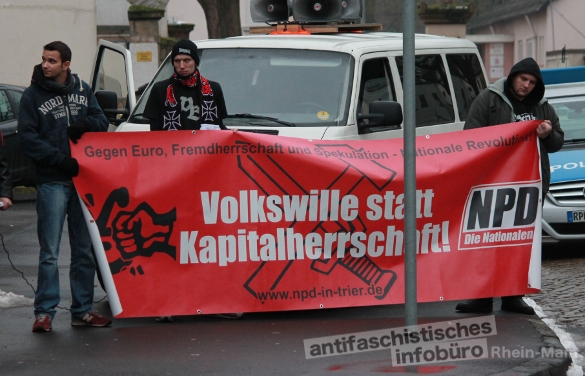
[144,39,227,131]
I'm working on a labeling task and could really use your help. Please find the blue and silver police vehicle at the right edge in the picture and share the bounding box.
[542,66,585,242]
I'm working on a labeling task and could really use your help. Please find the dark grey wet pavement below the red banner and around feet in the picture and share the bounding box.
[0,196,571,376]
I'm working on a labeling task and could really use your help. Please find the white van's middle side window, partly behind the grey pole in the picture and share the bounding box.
[396,55,455,127]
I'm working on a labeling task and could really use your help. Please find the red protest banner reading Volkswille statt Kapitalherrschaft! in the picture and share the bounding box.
[72,122,541,317]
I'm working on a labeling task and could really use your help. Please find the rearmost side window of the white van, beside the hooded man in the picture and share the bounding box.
[447,54,487,120]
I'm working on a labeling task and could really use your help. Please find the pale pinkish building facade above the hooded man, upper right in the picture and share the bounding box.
[467,0,585,82]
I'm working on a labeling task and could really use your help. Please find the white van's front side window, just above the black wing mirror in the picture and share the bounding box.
[357,58,396,117]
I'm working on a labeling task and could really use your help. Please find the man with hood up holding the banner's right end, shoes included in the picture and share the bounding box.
[455,57,564,315]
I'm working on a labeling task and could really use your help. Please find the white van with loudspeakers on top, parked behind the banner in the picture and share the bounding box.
[91,30,487,140]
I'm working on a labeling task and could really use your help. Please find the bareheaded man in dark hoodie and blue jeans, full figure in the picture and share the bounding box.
[17,41,111,332]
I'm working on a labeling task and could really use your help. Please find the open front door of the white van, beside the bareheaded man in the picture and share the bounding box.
[91,39,136,131]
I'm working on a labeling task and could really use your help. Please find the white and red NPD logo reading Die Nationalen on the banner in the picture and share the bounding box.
[459,182,540,249]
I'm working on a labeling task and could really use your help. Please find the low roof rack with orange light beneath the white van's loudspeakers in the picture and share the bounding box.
[250,22,382,35]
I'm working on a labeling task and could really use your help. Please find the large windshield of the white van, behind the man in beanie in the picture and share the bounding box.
[132,48,354,127]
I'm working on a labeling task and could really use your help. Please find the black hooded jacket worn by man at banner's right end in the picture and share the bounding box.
[463,58,565,196]
